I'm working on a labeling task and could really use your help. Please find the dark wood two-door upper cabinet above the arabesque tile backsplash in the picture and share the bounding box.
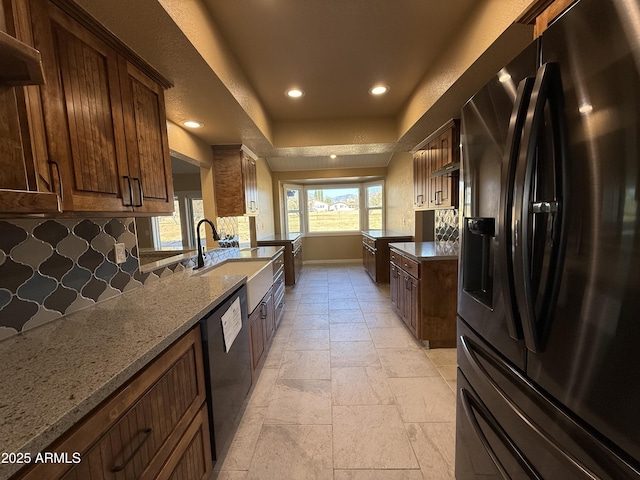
[0,0,173,215]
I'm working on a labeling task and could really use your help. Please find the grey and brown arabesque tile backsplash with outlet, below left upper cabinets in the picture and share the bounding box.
[0,218,142,338]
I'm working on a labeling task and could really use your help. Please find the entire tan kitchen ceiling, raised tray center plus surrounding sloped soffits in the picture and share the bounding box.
[76,0,535,171]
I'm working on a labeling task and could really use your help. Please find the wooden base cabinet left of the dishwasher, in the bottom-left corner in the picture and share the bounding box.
[12,327,213,480]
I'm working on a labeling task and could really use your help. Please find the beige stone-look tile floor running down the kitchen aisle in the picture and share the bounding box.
[214,264,456,480]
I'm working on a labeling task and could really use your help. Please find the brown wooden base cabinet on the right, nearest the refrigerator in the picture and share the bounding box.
[389,248,458,348]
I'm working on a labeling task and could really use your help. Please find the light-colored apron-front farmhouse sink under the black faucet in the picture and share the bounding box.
[200,260,273,313]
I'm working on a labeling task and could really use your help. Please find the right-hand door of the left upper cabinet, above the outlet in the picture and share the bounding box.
[119,57,173,213]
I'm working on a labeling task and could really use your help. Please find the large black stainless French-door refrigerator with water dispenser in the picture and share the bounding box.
[456,0,640,480]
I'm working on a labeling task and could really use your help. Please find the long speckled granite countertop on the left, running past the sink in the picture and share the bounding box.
[0,247,282,480]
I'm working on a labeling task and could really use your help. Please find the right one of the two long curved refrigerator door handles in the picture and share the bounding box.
[513,62,567,353]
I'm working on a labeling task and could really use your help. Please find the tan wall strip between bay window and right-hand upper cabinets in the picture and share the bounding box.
[385,152,415,235]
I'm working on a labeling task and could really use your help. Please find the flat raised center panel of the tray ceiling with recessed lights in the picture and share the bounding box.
[204,0,478,121]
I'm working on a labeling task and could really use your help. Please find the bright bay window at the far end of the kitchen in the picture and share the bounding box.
[284,180,384,235]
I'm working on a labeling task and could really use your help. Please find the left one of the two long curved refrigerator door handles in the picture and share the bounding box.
[498,77,534,340]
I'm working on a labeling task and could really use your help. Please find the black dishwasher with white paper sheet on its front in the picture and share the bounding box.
[200,285,251,460]
